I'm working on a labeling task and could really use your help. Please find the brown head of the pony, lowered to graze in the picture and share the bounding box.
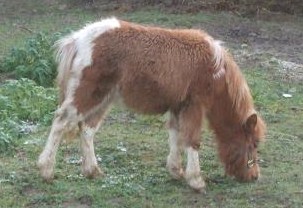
[219,113,265,182]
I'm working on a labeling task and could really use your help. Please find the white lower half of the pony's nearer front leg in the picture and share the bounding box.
[185,147,205,191]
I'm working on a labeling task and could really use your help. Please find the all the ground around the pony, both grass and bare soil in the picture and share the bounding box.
[0,0,303,207]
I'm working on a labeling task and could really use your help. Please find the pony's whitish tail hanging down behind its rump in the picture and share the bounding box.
[54,36,77,105]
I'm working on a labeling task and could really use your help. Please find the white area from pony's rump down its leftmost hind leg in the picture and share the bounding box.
[38,18,120,180]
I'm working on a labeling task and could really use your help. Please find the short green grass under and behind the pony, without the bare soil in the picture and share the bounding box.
[0,4,303,207]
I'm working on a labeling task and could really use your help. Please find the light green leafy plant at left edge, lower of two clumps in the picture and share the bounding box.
[0,78,57,150]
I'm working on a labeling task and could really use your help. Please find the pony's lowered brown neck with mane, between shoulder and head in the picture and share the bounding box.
[208,56,254,141]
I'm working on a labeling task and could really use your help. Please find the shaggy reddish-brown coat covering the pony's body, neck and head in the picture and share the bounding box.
[39,18,265,189]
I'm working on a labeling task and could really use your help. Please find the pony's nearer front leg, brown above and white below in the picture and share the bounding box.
[179,103,205,191]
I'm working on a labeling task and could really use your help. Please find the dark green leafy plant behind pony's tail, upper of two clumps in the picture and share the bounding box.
[0,33,61,86]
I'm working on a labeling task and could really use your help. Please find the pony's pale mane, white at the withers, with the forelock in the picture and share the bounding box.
[210,44,266,140]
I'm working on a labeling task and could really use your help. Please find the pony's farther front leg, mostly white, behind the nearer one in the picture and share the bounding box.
[166,112,184,179]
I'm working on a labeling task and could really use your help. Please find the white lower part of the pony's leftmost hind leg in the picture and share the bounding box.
[38,103,79,181]
